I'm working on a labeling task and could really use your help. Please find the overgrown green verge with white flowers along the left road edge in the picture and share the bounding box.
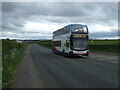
[2,40,27,88]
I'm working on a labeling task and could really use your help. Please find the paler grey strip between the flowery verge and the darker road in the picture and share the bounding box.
[12,46,43,88]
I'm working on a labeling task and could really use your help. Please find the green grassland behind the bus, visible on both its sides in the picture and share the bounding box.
[37,40,120,53]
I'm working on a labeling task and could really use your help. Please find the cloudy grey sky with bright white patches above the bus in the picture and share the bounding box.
[1,2,118,39]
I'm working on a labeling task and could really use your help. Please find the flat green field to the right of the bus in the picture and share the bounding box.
[89,40,120,53]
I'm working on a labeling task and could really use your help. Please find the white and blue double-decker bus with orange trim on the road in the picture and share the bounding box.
[52,24,89,56]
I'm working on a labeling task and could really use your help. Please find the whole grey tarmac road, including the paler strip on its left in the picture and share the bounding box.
[13,44,118,88]
